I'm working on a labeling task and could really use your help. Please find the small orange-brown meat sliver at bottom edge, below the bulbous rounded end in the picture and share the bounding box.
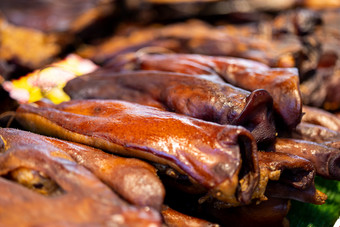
[162,206,219,227]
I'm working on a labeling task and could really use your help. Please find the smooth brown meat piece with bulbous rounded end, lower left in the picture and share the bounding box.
[0,128,165,210]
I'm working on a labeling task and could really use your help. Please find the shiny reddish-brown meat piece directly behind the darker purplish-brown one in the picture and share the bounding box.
[107,54,302,128]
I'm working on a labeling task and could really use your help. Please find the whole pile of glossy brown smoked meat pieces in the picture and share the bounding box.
[0,0,340,226]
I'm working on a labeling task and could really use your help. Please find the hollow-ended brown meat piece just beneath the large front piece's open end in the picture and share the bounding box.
[258,152,327,204]
